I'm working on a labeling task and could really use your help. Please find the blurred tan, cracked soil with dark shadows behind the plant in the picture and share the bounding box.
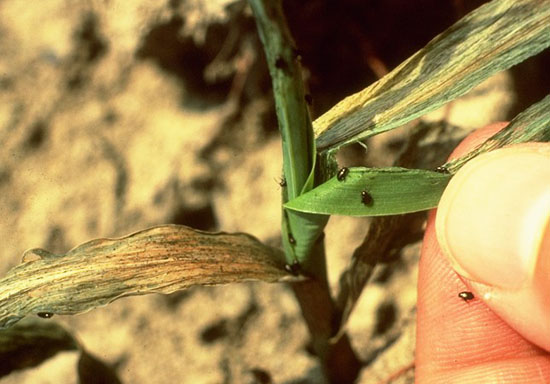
[0,0,550,384]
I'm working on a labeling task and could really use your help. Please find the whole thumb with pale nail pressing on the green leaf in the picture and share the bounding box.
[436,143,550,351]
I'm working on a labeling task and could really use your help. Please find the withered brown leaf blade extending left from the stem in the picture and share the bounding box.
[0,225,290,328]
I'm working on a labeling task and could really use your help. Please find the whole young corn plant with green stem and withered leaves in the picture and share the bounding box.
[0,0,550,383]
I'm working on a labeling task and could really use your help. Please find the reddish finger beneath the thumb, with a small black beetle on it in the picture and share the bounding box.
[415,123,550,384]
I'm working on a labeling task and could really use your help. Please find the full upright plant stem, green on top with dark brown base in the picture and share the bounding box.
[249,0,360,383]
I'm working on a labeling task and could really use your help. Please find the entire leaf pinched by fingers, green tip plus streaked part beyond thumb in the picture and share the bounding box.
[285,92,550,216]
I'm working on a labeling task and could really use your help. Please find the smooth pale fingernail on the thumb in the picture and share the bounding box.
[436,143,550,289]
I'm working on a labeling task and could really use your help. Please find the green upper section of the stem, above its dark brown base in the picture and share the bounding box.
[245,0,320,272]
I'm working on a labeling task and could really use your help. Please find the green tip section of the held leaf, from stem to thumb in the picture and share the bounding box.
[285,167,451,216]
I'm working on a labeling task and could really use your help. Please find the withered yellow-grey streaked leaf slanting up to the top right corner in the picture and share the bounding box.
[313,0,550,150]
